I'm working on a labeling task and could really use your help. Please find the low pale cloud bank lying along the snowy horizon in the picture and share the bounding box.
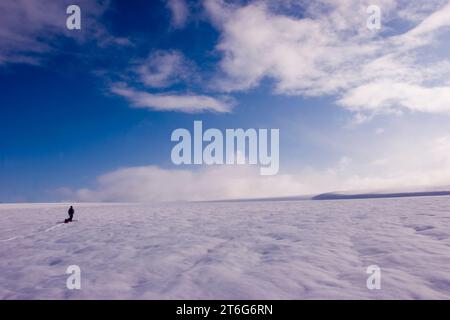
[71,136,450,202]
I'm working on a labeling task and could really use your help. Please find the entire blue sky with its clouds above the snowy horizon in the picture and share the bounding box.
[0,0,450,202]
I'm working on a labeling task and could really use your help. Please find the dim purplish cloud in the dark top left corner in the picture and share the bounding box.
[0,0,130,65]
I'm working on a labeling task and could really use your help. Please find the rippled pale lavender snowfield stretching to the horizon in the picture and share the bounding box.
[0,197,450,299]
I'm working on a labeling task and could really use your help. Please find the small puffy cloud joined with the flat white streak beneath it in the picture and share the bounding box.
[110,50,235,113]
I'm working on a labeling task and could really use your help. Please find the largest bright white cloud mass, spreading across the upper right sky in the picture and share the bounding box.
[205,0,450,119]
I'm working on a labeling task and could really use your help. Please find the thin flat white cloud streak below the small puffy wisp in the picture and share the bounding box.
[111,84,233,113]
